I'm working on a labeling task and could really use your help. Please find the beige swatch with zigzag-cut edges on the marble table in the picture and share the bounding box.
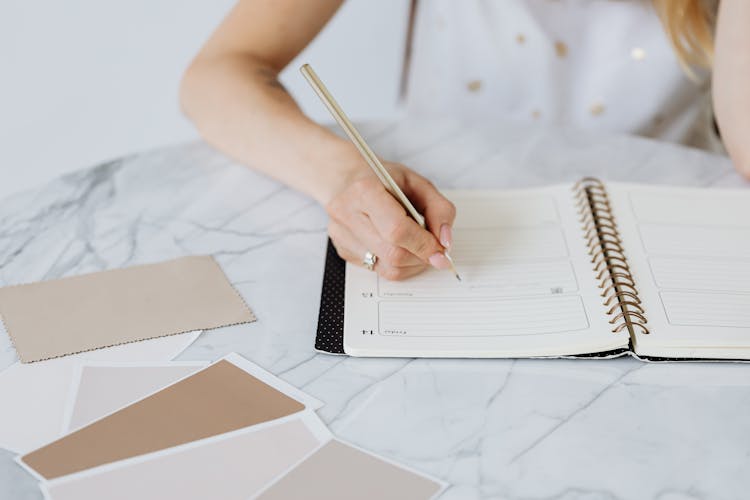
[0,256,255,363]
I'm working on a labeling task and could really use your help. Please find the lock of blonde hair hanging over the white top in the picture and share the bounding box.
[653,0,719,73]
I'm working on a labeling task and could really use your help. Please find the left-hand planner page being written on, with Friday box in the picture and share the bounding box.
[344,186,627,357]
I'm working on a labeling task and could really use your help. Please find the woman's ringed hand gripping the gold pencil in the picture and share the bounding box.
[326,162,456,280]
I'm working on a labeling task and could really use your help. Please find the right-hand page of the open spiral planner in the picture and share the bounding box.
[607,184,750,358]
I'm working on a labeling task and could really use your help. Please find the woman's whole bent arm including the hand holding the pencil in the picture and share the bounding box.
[180,0,455,279]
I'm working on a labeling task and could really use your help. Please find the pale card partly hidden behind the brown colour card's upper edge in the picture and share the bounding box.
[64,364,205,432]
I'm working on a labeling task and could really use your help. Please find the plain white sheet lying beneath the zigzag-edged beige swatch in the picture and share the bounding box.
[0,331,201,453]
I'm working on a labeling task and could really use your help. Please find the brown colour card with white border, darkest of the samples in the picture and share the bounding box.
[21,360,304,479]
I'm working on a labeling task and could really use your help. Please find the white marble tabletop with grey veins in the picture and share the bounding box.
[0,119,750,500]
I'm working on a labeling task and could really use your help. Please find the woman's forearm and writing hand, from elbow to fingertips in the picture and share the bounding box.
[180,47,456,279]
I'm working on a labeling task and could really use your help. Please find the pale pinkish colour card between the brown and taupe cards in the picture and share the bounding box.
[42,420,320,500]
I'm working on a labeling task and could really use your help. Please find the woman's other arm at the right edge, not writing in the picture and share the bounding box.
[713,0,750,179]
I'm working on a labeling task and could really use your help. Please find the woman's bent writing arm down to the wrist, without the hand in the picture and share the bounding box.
[180,0,356,203]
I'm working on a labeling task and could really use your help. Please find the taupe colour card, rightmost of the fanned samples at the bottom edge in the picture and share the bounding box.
[258,440,441,500]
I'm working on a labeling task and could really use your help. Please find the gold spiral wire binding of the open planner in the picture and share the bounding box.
[573,177,649,340]
